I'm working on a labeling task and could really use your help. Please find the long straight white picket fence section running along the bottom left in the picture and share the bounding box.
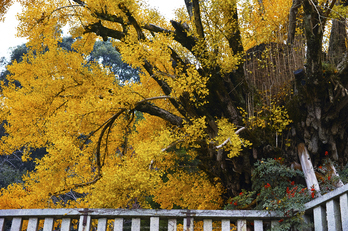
[0,209,282,231]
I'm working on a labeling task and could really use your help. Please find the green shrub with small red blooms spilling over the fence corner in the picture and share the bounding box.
[225,158,312,230]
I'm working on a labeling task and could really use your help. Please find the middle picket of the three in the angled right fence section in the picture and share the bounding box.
[326,200,341,231]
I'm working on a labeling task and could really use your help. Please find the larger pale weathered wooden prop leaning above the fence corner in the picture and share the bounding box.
[297,143,320,193]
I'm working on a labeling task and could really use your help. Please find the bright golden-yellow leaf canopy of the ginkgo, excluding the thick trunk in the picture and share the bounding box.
[0,0,342,209]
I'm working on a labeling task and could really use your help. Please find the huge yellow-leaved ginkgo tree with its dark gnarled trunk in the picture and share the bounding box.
[0,0,348,209]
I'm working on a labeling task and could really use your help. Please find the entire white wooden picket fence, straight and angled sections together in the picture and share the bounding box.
[0,184,348,231]
